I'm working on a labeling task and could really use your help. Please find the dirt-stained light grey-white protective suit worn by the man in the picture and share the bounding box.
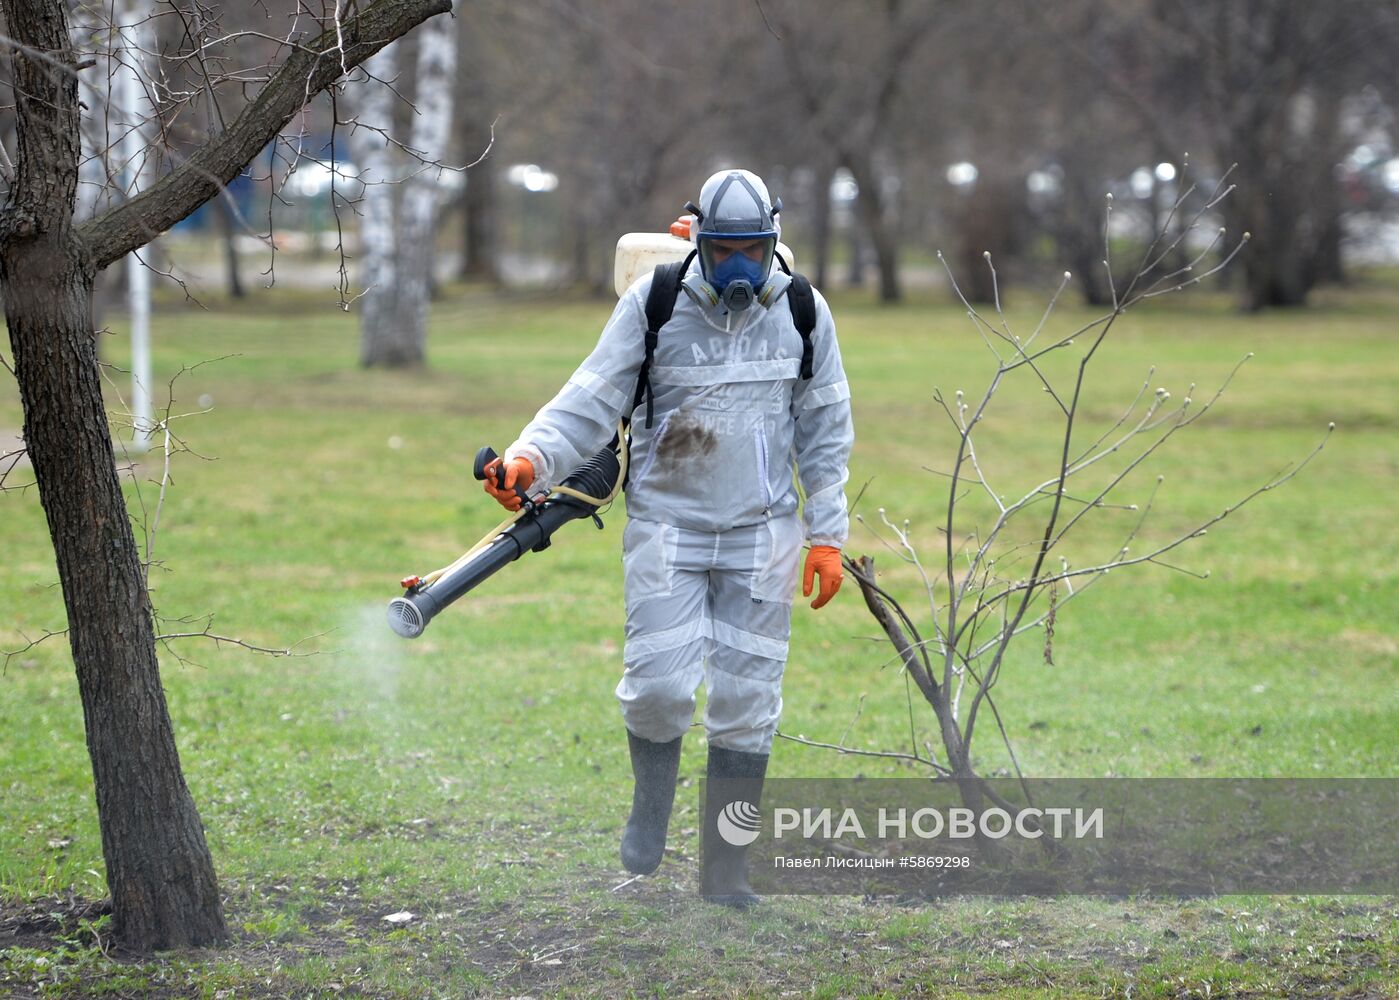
[505,215,853,754]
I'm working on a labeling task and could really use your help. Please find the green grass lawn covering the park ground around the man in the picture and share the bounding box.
[0,271,1399,997]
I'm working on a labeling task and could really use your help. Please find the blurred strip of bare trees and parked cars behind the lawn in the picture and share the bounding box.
[13,0,1399,348]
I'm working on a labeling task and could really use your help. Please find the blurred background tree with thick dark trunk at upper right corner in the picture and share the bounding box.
[1020,0,1399,309]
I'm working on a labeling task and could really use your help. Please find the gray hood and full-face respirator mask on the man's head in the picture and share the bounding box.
[686,169,782,312]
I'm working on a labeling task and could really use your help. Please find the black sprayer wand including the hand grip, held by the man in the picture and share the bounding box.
[389,434,627,639]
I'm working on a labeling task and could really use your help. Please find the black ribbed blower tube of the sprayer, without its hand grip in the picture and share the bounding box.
[388,448,621,639]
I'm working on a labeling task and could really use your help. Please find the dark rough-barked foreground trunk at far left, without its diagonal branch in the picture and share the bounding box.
[0,0,228,951]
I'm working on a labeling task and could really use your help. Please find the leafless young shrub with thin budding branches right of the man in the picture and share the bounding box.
[788,172,1329,848]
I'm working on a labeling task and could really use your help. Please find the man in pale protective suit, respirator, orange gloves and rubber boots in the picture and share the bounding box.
[485,171,853,908]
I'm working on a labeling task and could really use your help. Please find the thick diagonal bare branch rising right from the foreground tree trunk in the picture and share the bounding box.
[78,0,452,267]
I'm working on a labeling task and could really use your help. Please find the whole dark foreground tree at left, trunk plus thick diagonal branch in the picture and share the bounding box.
[0,0,450,951]
